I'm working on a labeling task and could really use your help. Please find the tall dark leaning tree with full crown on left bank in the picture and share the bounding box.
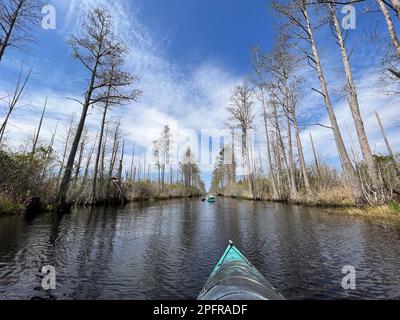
[57,9,140,211]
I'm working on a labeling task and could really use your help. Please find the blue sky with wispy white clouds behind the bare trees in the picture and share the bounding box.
[0,0,400,190]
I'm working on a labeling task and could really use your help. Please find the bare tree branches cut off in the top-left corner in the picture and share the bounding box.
[0,0,42,62]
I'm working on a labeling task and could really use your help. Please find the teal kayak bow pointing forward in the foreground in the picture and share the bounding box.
[197,241,284,300]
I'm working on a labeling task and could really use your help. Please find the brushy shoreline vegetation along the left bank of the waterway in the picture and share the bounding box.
[0,149,206,215]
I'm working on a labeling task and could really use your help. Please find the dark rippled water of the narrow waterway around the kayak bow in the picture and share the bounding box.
[0,199,400,299]
